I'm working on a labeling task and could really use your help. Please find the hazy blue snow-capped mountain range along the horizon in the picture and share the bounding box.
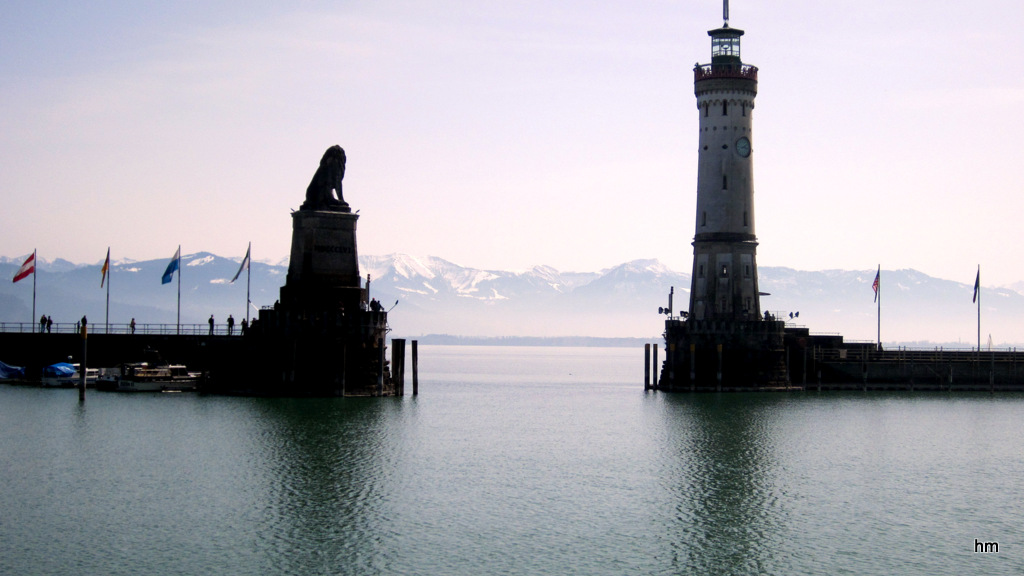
[0,252,1024,346]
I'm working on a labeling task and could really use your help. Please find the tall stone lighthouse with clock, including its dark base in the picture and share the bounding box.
[657,0,787,390]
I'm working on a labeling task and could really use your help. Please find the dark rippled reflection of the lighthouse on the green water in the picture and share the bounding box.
[663,395,788,574]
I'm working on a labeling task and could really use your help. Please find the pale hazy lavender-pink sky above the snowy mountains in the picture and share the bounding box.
[0,0,1024,285]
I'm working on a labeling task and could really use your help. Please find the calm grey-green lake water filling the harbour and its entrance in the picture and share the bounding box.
[0,346,1024,576]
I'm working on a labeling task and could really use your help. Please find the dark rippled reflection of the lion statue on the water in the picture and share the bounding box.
[249,399,396,574]
